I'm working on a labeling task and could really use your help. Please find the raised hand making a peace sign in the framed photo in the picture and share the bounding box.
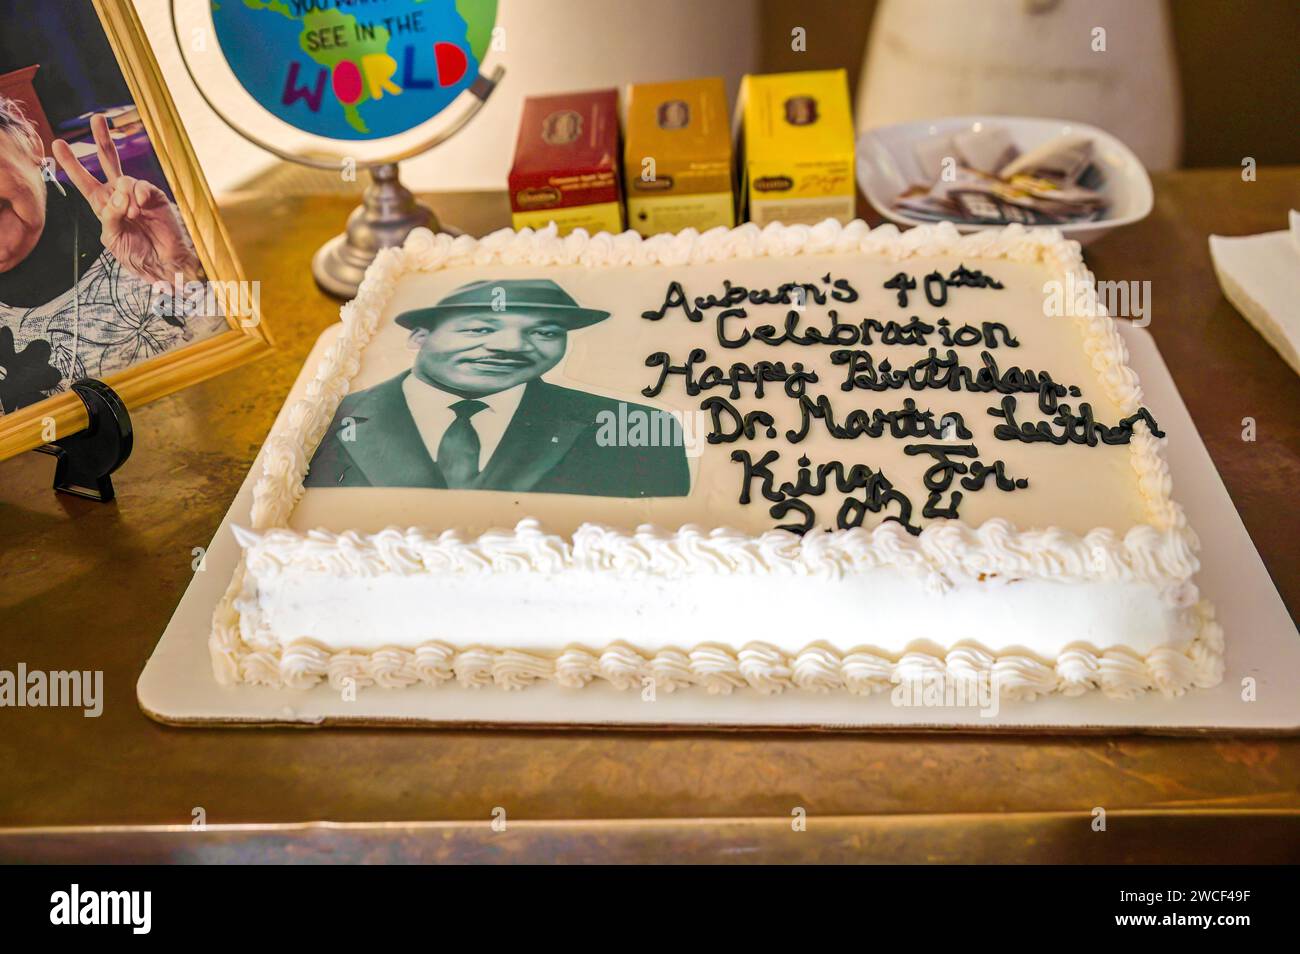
[52,113,199,285]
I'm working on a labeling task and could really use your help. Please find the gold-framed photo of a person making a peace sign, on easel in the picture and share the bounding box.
[0,0,270,459]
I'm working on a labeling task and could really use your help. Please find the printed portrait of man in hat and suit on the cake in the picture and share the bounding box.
[306,279,690,496]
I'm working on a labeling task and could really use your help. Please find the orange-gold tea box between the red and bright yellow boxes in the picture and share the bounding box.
[623,78,736,235]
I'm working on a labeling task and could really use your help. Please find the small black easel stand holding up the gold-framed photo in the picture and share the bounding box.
[36,378,133,503]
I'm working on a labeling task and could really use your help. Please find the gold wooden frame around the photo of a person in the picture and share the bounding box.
[0,0,273,460]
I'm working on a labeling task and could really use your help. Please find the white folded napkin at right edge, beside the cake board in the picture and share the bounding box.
[1210,209,1300,374]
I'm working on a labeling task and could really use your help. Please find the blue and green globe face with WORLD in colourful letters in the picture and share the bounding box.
[211,0,497,140]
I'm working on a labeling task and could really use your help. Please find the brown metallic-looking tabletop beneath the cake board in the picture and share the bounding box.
[0,168,1300,860]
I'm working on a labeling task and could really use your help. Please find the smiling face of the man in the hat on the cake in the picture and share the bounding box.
[411,311,567,396]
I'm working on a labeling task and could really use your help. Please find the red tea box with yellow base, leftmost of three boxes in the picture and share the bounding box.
[510,90,623,235]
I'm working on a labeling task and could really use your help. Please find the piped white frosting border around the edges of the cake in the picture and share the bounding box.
[209,220,1222,694]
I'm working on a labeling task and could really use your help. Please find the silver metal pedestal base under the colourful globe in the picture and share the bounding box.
[312,162,459,299]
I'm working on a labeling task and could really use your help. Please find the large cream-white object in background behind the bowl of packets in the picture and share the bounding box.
[857,0,1182,169]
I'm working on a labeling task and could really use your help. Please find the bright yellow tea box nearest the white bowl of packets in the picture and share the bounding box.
[736,70,855,225]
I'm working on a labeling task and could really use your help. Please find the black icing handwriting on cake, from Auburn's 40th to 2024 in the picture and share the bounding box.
[641,265,1164,534]
